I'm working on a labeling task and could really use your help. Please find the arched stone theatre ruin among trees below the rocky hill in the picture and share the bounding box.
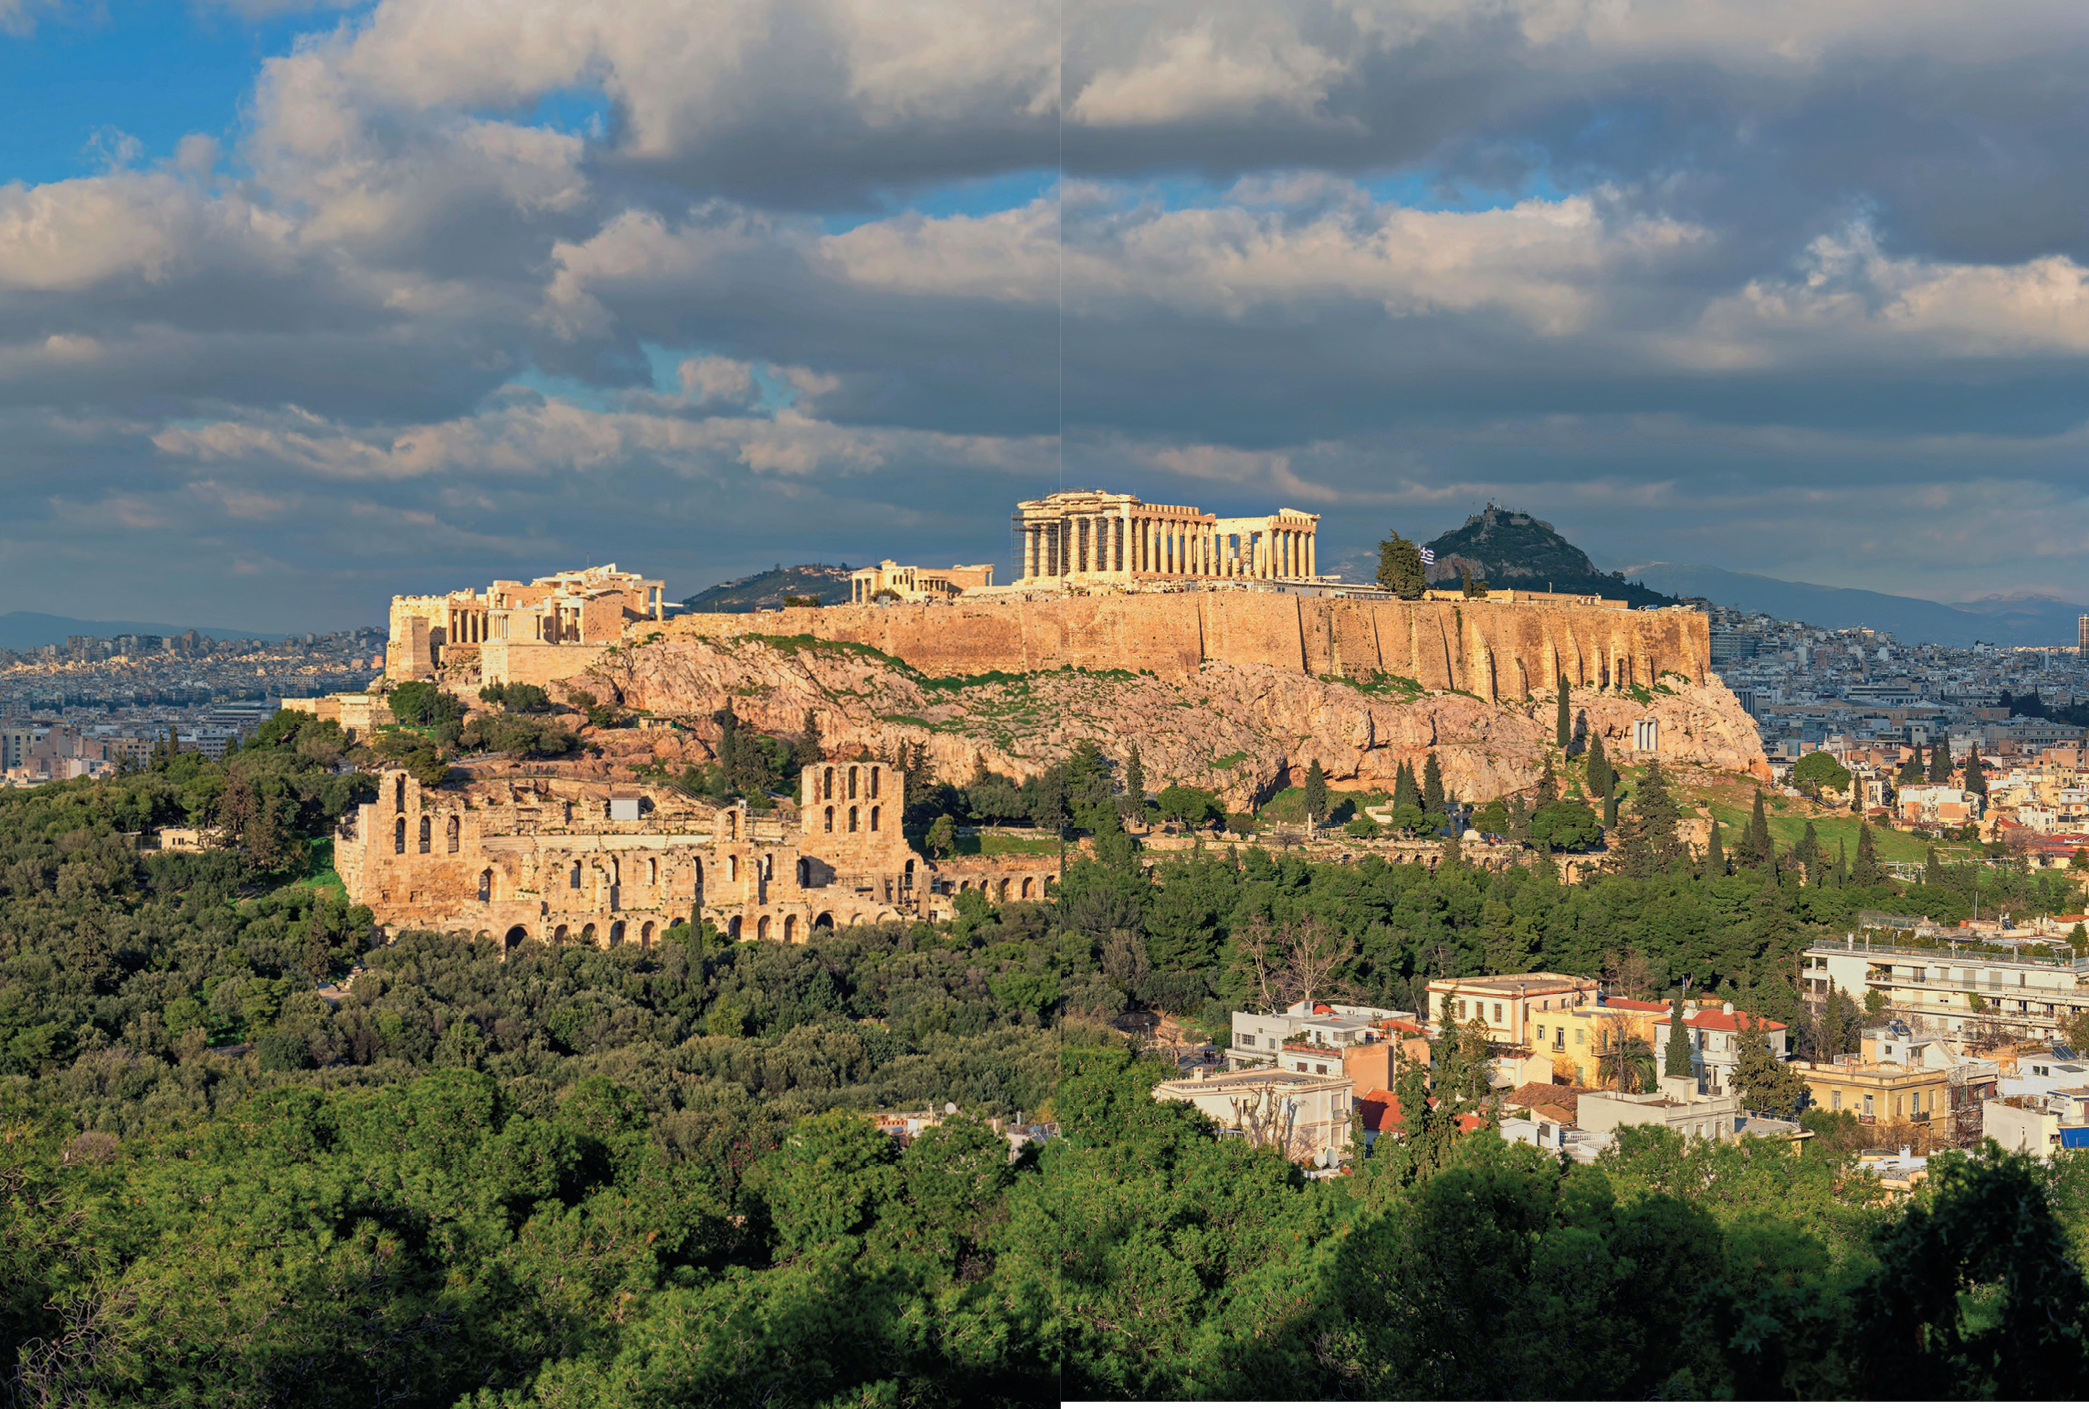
[334,763,1059,947]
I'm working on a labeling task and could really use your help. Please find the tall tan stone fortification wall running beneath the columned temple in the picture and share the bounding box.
[660,592,1711,700]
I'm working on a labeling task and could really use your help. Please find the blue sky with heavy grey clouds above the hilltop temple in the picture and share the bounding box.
[0,0,2089,631]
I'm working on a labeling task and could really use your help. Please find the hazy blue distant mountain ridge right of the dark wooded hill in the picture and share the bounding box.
[1629,562,2089,646]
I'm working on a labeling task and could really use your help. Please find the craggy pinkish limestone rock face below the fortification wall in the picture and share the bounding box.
[564,636,1767,807]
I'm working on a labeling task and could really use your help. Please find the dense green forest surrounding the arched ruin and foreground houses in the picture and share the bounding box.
[0,719,2089,1405]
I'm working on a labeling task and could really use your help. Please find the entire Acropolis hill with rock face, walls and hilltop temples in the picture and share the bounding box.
[371,491,1767,807]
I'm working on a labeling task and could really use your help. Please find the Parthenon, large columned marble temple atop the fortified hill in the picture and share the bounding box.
[1015,489,1320,585]
